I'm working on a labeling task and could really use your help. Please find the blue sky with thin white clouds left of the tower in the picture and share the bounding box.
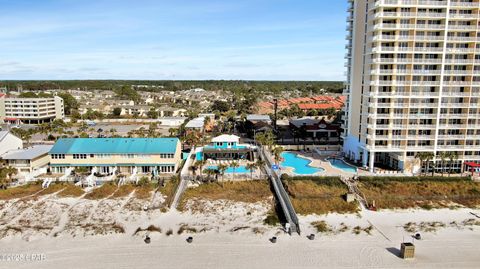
[0,0,347,80]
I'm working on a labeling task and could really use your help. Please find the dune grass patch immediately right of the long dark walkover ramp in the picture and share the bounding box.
[284,177,359,215]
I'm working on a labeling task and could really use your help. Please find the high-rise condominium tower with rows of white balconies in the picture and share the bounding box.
[343,0,480,173]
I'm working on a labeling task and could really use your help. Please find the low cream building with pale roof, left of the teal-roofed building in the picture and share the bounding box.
[0,145,53,174]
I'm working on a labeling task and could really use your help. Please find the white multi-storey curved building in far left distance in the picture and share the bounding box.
[0,94,65,124]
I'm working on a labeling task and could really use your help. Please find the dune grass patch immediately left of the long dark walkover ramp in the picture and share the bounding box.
[179,181,272,209]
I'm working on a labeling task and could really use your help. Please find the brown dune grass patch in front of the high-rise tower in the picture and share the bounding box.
[359,179,480,209]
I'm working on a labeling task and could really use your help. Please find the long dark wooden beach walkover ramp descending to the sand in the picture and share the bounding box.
[259,146,300,235]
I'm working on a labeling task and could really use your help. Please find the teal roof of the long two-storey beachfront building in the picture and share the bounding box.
[50,138,180,154]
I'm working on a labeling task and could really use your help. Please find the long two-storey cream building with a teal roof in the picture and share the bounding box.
[49,138,182,174]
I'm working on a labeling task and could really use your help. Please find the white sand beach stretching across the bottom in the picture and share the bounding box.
[0,189,480,268]
